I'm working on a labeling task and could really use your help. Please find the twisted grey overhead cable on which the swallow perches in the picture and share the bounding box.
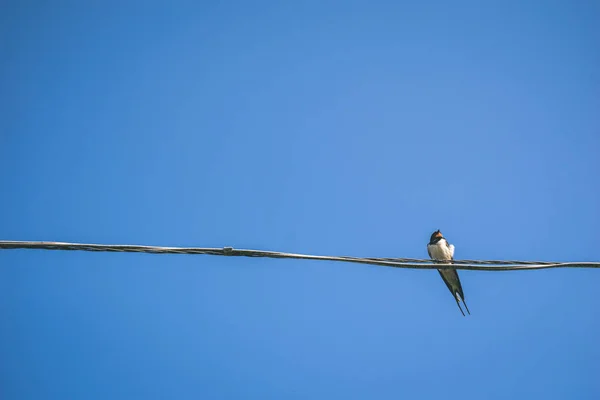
[0,240,600,271]
